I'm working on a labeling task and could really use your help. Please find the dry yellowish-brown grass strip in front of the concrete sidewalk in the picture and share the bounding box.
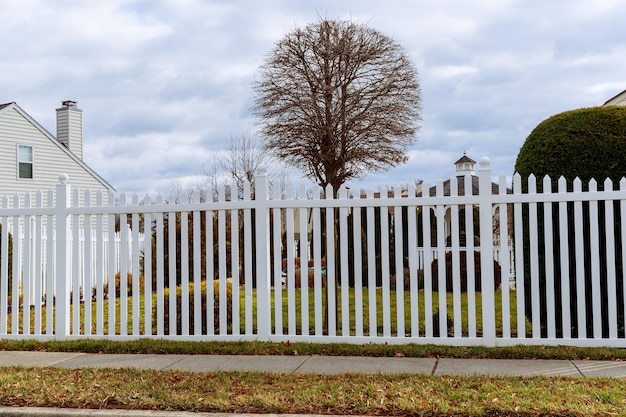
[0,368,626,416]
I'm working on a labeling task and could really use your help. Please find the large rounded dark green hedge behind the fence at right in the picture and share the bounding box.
[515,106,626,337]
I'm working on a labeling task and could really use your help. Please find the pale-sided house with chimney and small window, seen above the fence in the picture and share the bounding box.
[0,101,115,204]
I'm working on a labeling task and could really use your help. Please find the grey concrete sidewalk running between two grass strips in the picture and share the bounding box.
[0,351,626,378]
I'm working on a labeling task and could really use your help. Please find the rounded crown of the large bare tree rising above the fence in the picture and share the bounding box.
[253,19,421,192]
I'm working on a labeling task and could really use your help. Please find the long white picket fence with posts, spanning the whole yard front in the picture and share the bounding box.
[0,158,626,347]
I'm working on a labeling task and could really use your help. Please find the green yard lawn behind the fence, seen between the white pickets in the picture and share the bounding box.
[7,288,530,337]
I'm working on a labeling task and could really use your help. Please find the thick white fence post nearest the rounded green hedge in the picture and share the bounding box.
[478,156,496,346]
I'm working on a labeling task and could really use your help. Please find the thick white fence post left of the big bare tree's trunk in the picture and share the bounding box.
[254,168,272,340]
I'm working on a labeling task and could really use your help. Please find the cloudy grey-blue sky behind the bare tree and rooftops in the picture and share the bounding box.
[0,0,626,194]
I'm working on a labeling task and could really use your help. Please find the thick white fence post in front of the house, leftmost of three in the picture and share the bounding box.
[54,174,71,339]
